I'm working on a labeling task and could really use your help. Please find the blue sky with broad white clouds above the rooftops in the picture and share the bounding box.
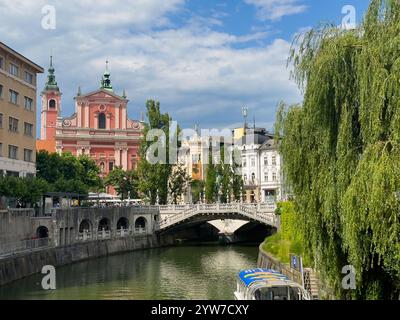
[0,0,369,135]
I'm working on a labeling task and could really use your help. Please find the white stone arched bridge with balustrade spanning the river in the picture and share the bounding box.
[157,203,280,232]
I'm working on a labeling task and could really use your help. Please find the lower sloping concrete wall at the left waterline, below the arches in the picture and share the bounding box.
[0,235,159,285]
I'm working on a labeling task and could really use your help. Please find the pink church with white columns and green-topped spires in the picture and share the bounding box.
[37,59,144,181]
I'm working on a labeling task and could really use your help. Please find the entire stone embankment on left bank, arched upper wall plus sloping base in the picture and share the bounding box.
[0,207,164,285]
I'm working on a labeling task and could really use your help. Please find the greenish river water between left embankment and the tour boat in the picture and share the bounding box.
[0,244,258,300]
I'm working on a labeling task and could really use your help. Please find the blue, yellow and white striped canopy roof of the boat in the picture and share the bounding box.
[239,269,290,287]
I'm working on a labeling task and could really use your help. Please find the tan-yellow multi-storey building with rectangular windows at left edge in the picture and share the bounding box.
[0,42,44,177]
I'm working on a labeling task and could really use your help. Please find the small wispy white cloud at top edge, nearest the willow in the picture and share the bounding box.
[245,0,307,21]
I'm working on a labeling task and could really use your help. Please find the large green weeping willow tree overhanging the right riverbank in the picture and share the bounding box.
[276,0,400,299]
